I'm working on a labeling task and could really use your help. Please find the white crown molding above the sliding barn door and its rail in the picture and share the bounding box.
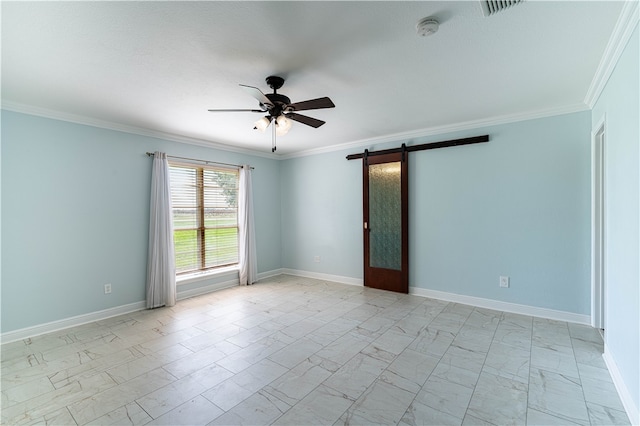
[279,102,589,160]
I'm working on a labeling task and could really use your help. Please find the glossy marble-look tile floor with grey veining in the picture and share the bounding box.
[1,275,629,425]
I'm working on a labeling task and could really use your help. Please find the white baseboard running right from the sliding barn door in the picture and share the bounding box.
[409,287,591,325]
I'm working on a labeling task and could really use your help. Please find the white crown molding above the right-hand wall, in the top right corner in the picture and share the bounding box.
[584,0,640,108]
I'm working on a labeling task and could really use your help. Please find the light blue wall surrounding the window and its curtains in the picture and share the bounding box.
[2,111,282,332]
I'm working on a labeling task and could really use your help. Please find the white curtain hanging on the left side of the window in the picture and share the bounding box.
[147,152,176,309]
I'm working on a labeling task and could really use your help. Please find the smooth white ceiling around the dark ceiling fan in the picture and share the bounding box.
[1,0,623,155]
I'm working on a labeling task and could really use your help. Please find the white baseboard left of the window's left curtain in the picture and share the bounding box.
[0,301,146,344]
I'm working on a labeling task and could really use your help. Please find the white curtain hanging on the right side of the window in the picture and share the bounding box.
[238,165,258,285]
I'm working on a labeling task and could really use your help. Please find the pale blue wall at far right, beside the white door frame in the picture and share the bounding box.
[592,26,640,413]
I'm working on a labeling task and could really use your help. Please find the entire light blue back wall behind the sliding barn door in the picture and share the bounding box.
[281,111,591,315]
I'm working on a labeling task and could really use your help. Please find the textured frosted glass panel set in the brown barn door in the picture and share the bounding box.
[368,162,402,270]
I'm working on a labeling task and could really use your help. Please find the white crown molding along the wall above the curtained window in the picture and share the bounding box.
[2,99,279,160]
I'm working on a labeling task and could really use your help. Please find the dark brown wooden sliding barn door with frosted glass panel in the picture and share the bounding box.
[362,152,409,293]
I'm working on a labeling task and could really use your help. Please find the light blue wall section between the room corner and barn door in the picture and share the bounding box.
[281,151,363,278]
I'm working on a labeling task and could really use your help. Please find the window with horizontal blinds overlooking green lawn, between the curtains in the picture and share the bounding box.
[169,163,239,275]
